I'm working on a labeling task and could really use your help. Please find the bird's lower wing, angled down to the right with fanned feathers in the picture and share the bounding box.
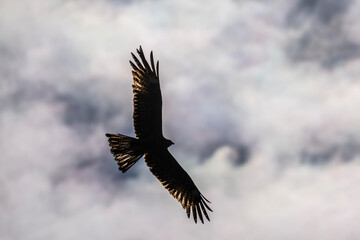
[145,149,212,223]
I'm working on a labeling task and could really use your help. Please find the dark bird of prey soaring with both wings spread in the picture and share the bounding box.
[106,46,212,223]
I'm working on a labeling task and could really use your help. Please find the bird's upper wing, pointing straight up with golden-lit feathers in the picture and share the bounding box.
[130,46,162,138]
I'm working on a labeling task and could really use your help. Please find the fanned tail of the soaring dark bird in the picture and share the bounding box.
[106,133,144,173]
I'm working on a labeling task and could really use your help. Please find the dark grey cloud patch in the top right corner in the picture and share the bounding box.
[286,0,360,69]
